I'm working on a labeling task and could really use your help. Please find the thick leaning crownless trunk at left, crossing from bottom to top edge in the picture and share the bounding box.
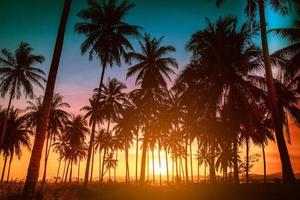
[21,0,72,200]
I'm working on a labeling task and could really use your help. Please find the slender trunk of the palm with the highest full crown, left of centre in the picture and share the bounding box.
[83,66,106,188]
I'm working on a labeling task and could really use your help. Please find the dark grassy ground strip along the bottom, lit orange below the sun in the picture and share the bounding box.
[0,183,300,200]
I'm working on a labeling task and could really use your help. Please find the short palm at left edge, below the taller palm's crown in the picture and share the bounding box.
[0,108,32,182]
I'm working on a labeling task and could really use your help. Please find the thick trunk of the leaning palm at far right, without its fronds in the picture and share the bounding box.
[258,0,296,183]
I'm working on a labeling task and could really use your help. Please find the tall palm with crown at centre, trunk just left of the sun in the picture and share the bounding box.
[126,34,178,183]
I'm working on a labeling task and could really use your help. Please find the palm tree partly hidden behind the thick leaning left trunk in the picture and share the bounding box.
[24,94,70,183]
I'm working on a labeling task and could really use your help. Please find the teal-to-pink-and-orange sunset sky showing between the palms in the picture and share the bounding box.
[0,0,300,178]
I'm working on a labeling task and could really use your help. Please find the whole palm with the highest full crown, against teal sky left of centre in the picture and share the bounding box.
[75,0,139,186]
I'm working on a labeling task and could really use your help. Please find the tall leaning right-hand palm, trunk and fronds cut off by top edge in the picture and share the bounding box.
[217,0,296,182]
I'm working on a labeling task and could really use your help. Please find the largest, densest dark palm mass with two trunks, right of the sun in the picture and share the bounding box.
[175,17,263,182]
